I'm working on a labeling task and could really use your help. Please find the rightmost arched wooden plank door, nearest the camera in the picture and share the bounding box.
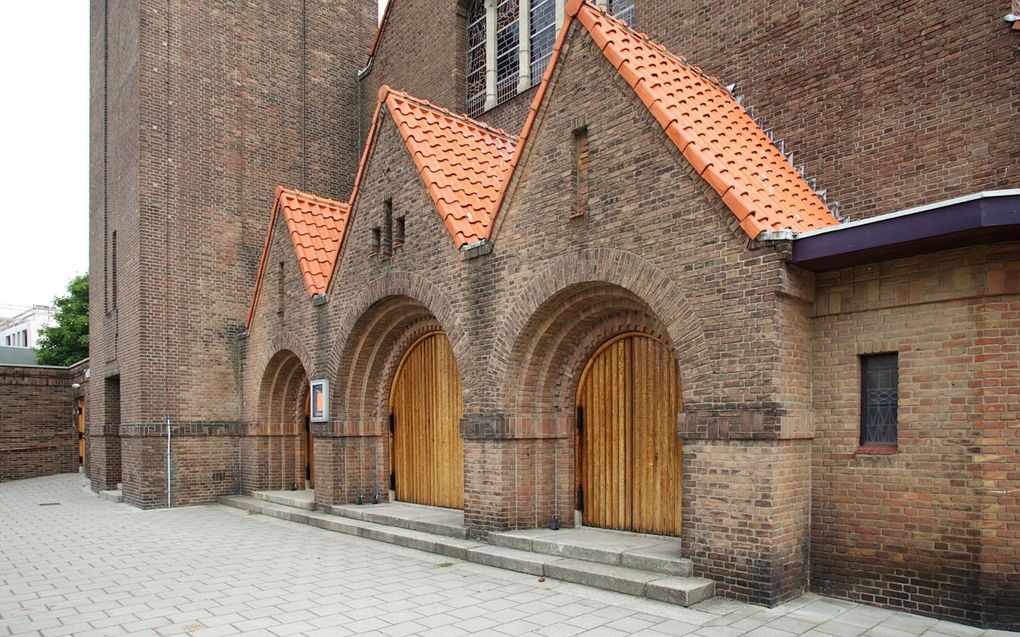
[577,333,681,535]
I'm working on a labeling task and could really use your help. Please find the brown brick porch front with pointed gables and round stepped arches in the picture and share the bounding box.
[243,22,808,602]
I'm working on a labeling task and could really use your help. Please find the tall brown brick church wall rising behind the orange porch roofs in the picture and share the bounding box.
[364,0,1020,218]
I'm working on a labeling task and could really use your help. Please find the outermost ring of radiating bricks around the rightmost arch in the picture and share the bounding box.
[491,248,710,409]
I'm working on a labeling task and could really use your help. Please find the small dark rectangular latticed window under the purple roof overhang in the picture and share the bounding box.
[861,353,900,446]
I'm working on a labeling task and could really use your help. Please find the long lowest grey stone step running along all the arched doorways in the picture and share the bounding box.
[219,495,715,606]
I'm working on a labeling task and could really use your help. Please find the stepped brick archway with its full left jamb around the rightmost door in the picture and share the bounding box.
[466,249,708,528]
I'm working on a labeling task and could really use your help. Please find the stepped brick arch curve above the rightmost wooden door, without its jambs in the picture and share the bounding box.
[493,249,710,426]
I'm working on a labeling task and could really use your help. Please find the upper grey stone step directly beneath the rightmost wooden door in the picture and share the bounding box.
[489,528,694,577]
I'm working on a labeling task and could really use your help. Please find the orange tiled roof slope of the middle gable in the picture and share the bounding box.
[379,87,517,248]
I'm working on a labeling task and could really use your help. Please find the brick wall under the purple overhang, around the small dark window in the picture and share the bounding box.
[811,244,1020,626]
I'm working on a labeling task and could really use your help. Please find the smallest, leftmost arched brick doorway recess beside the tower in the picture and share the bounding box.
[250,350,314,489]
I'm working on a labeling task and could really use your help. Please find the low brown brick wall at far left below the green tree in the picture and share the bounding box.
[0,361,88,482]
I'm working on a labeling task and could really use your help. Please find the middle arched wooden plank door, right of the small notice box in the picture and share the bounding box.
[391,332,464,509]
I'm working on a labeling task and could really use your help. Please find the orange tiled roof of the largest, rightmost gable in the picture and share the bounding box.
[491,0,838,238]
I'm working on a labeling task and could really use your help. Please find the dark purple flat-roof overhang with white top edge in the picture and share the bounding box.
[783,189,1020,272]
